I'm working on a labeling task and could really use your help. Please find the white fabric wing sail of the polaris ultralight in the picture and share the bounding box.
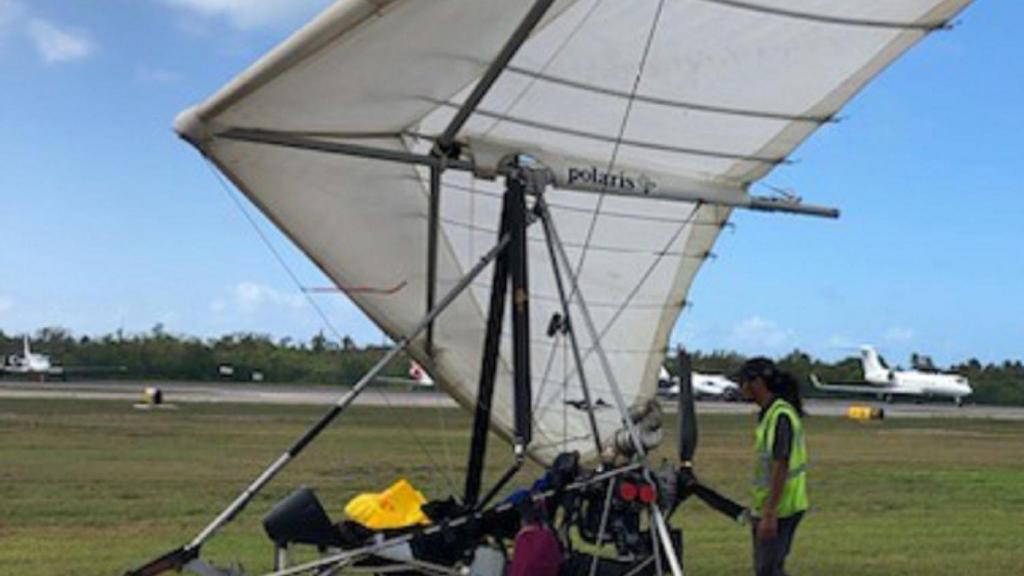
[176,0,969,460]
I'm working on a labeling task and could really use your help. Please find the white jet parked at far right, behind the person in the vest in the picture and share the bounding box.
[811,345,974,406]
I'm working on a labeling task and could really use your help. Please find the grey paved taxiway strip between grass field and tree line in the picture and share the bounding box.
[0,381,1024,420]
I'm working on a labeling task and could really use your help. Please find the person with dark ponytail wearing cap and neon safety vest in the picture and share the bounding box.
[734,358,809,576]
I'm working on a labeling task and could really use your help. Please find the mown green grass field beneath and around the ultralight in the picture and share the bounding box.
[0,401,1024,576]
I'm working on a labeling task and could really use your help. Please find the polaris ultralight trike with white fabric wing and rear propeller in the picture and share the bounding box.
[130,0,968,576]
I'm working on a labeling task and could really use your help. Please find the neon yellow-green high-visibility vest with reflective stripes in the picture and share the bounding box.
[754,399,809,518]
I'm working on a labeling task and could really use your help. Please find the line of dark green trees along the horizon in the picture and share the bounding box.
[0,324,1024,406]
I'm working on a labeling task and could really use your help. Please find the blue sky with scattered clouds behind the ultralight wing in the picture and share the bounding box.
[0,0,1024,363]
